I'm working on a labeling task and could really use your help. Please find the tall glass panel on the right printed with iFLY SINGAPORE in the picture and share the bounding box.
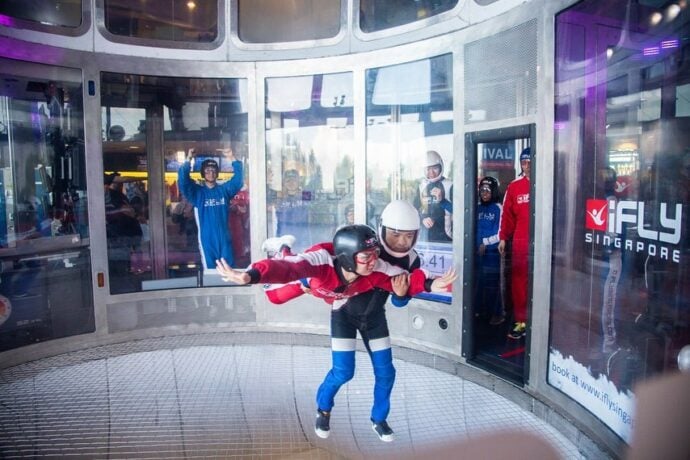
[548,0,690,442]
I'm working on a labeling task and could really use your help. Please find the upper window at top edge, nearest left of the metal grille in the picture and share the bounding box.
[359,0,458,32]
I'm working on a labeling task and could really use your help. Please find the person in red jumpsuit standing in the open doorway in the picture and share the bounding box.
[498,147,532,340]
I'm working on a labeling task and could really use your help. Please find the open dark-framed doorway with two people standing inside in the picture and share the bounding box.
[463,125,536,385]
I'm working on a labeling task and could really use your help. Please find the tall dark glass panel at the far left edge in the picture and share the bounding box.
[0,60,94,351]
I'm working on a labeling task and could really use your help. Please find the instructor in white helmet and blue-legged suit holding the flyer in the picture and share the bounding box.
[314,200,420,442]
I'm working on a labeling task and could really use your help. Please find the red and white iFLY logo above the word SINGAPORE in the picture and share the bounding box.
[585,199,683,244]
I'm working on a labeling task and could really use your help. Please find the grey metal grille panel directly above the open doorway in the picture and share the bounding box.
[464,20,537,123]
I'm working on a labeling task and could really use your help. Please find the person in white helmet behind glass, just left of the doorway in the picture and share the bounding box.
[415,150,453,241]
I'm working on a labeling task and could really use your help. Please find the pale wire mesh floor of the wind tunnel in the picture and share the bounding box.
[0,334,584,459]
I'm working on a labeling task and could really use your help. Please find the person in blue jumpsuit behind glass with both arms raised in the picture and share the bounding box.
[177,149,244,271]
